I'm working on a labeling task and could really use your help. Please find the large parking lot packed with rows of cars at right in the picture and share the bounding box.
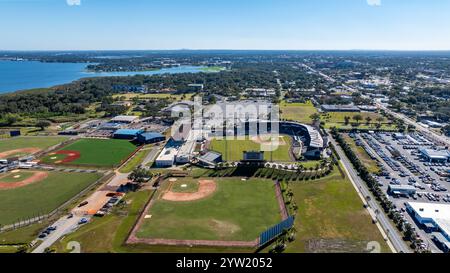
[349,133,450,252]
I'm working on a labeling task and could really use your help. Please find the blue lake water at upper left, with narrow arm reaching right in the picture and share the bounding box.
[0,61,202,93]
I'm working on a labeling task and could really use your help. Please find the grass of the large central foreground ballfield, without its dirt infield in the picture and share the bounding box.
[136,178,281,241]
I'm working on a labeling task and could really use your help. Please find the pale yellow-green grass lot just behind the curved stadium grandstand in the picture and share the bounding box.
[280,101,318,124]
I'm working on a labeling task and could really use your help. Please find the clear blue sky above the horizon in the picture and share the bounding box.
[0,0,450,50]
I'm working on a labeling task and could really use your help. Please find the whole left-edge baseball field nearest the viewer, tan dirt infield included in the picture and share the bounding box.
[0,170,102,225]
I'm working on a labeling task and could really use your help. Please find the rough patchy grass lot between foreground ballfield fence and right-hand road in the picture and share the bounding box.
[287,168,389,253]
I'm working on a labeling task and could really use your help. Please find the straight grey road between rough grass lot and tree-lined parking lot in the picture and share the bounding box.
[330,138,411,253]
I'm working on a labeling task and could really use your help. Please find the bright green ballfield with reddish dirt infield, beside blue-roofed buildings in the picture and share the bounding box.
[41,139,136,168]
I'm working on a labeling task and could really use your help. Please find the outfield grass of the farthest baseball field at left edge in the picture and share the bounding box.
[0,137,68,152]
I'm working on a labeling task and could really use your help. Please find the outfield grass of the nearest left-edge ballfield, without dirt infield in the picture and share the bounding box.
[0,172,102,225]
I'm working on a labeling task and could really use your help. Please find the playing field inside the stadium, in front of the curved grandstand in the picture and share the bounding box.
[209,136,292,162]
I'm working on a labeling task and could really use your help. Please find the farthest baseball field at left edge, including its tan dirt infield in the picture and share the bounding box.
[0,137,68,158]
